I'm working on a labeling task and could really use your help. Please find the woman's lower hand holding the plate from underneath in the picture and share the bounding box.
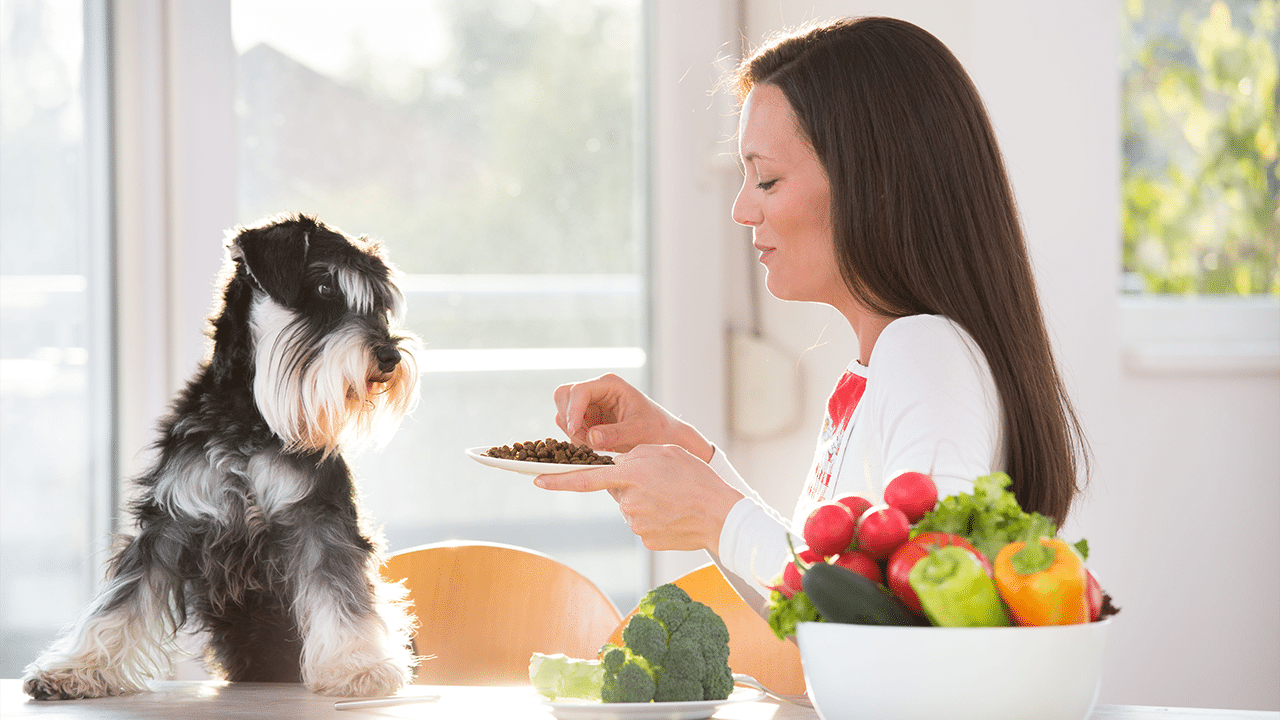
[534,445,742,552]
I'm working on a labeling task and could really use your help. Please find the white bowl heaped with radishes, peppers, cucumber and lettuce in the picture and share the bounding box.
[769,473,1117,720]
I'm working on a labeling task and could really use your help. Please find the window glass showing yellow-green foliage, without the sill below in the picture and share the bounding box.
[1121,0,1280,296]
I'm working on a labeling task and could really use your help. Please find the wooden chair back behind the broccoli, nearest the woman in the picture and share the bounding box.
[608,564,805,694]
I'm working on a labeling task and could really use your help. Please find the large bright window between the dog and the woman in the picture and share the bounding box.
[232,0,649,609]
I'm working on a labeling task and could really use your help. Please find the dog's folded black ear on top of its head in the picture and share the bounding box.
[229,218,316,307]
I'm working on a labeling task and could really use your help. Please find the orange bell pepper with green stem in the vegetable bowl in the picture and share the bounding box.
[993,538,1089,625]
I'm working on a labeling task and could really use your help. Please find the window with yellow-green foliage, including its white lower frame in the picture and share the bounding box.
[1120,0,1280,375]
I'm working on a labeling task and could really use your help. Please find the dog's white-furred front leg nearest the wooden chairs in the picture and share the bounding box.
[292,518,413,697]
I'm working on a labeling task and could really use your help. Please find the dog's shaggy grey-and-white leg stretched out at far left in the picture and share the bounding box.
[22,528,183,700]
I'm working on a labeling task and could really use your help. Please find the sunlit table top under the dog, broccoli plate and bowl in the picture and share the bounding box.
[0,679,1280,720]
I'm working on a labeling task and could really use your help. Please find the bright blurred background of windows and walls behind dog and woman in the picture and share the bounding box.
[0,0,1280,710]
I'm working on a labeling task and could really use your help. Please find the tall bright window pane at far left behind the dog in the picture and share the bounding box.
[0,0,115,678]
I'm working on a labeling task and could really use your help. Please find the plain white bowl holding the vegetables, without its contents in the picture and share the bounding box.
[796,620,1111,720]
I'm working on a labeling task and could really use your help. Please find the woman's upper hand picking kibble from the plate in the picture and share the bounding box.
[554,373,714,462]
